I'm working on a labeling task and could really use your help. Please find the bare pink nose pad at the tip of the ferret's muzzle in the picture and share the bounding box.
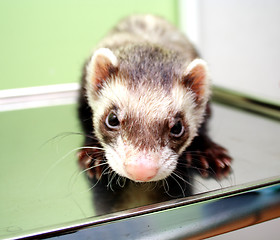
[125,162,159,182]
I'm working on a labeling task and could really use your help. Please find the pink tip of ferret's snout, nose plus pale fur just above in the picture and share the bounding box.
[124,155,159,182]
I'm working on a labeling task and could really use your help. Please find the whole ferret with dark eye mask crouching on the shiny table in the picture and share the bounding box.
[79,15,231,182]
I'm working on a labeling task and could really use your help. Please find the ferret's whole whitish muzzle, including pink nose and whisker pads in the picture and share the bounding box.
[105,144,178,182]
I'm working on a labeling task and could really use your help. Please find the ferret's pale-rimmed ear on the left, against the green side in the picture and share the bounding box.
[86,48,118,91]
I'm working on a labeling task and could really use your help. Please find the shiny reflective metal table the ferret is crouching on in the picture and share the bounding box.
[0,94,280,239]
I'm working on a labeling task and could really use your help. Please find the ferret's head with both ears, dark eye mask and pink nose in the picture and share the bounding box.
[86,48,210,182]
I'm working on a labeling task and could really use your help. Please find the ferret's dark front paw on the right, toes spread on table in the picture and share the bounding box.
[186,141,232,179]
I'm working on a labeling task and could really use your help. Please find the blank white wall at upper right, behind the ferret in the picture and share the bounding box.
[180,0,280,106]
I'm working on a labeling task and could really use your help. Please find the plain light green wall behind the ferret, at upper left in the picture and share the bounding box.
[0,0,177,89]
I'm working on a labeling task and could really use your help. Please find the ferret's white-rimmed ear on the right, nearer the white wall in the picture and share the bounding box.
[183,59,210,102]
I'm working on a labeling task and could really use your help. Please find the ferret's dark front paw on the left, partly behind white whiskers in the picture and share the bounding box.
[78,148,104,180]
